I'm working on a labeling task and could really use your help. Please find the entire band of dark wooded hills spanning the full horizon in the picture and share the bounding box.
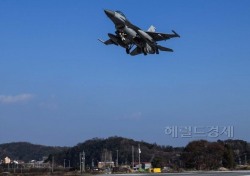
[0,136,250,170]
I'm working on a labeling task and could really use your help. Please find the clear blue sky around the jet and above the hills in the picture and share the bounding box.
[0,0,250,146]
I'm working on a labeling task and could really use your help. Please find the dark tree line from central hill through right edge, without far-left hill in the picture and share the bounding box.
[47,137,250,170]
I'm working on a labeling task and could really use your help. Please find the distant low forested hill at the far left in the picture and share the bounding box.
[0,142,68,162]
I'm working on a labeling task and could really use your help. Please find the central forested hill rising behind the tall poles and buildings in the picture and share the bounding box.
[51,137,184,167]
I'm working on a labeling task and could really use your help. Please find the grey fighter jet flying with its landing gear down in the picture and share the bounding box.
[98,10,180,56]
